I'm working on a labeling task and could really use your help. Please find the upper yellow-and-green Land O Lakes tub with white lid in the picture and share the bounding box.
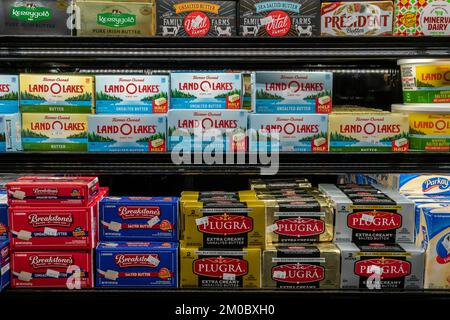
[398,59,450,103]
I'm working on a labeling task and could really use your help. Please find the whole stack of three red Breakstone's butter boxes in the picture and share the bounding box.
[6,176,108,289]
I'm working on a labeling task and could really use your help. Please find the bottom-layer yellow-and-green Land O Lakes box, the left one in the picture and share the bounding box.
[22,113,88,152]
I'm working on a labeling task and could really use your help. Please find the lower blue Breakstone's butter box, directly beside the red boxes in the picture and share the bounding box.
[95,242,178,288]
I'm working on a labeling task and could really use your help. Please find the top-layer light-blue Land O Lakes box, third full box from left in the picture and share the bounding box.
[170,72,242,109]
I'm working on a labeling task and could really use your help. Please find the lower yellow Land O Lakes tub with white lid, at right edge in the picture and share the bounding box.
[392,103,450,151]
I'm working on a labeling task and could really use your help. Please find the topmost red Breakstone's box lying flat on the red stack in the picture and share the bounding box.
[6,176,99,206]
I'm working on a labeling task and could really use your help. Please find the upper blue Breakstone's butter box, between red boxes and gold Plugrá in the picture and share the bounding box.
[99,197,178,242]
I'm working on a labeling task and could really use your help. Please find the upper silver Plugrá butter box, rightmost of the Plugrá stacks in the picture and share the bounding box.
[319,184,415,244]
